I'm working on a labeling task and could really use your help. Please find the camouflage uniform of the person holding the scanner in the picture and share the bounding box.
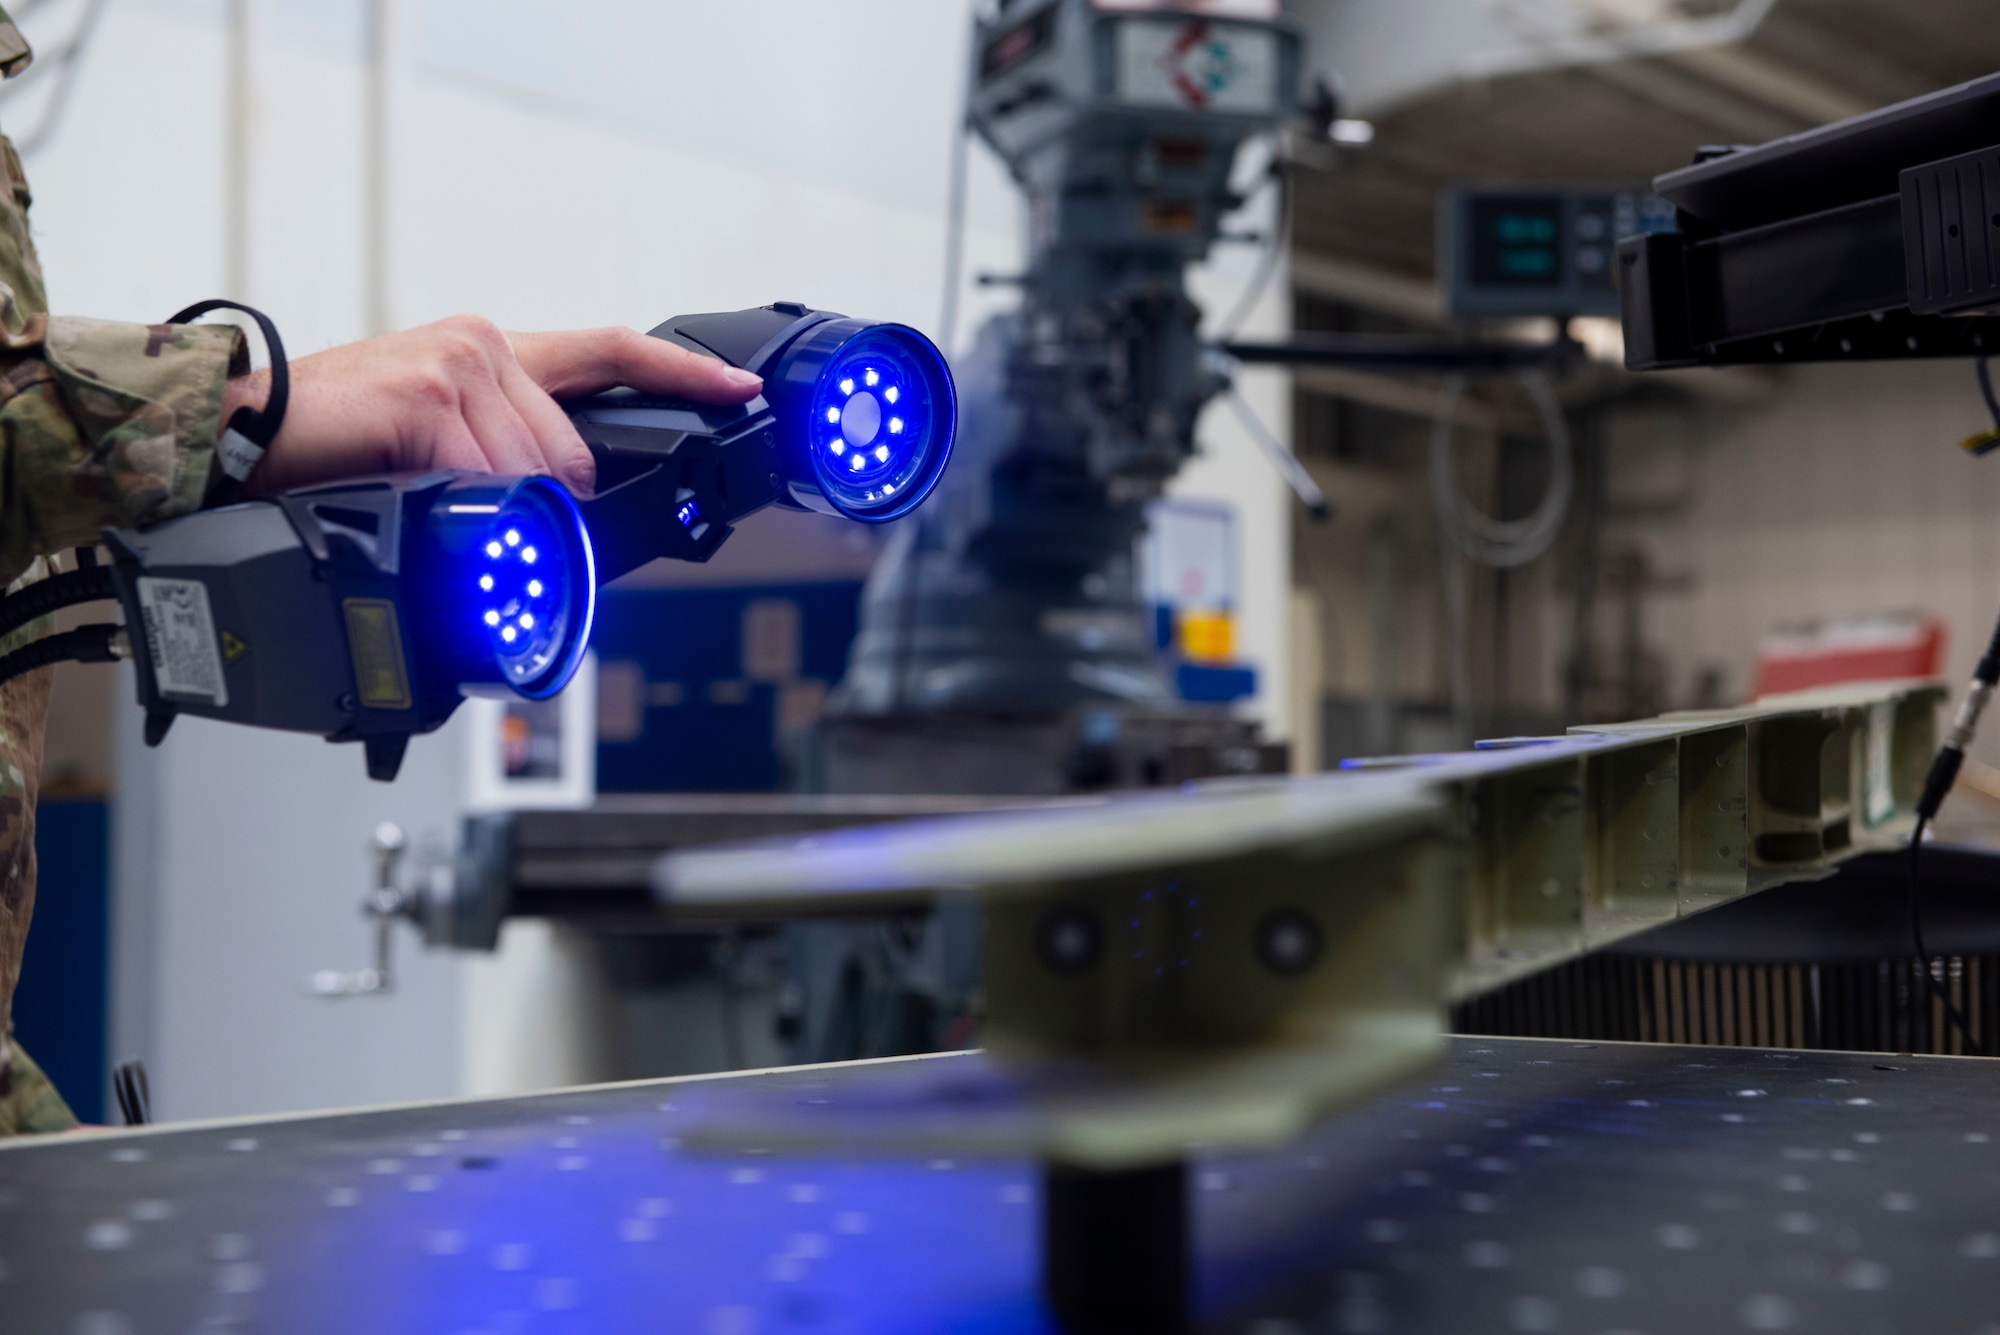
[0,10,246,1135]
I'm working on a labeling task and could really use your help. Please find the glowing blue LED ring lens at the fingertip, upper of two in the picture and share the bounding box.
[768,320,958,524]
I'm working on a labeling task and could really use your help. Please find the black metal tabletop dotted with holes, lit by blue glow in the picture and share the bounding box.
[0,1039,2000,1335]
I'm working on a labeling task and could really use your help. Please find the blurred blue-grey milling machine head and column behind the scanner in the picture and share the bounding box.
[828,0,1332,795]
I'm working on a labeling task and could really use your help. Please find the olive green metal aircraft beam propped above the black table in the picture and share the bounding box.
[652,681,1944,1171]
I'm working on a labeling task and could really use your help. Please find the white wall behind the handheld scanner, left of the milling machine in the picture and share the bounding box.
[19,0,1048,1117]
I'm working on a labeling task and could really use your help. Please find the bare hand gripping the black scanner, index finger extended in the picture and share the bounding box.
[222,316,764,496]
